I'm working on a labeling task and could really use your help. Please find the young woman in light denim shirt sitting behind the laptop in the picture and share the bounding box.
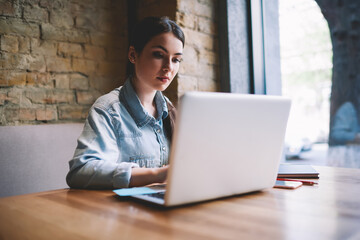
[66,17,185,189]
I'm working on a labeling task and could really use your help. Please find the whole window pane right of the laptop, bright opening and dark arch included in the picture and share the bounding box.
[279,0,360,168]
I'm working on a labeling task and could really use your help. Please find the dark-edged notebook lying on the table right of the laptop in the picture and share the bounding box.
[278,164,319,178]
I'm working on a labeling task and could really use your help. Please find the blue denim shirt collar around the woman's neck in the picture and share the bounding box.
[119,78,168,127]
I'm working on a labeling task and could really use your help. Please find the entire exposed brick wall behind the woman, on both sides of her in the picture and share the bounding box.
[0,0,219,125]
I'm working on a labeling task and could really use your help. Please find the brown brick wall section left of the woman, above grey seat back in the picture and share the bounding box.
[0,0,128,125]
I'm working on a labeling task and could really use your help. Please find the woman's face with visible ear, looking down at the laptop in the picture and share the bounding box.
[129,32,183,91]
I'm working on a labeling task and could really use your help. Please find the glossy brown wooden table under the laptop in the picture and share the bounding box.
[0,167,360,240]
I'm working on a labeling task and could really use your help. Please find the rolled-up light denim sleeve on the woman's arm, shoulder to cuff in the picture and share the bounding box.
[66,106,138,189]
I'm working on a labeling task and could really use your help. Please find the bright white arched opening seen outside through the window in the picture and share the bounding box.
[279,0,332,165]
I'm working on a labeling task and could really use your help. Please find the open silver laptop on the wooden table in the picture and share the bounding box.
[124,92,291,207]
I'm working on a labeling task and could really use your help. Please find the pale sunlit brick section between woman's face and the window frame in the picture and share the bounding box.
[176,0,220,96]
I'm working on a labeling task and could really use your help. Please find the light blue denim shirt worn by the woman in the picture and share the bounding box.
[66,79,170,189]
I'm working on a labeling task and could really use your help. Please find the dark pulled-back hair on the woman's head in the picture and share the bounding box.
[127,17,185,76]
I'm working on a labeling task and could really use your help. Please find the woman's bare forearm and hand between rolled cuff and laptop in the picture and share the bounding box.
[129,166,169,187]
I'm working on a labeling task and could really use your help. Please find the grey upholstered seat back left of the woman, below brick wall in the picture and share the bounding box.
[0,123,83,197]
